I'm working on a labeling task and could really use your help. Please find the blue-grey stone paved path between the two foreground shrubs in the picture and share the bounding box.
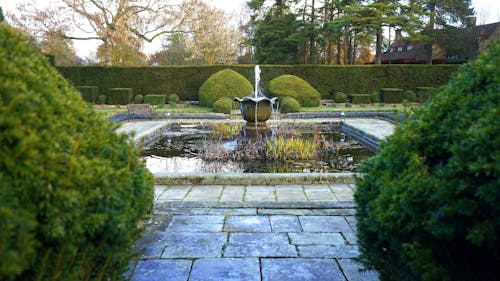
[131,184,378,281]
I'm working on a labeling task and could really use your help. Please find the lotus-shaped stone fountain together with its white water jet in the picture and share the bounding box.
[234,65,278,126]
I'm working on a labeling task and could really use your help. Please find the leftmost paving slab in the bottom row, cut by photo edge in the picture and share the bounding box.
[131,259,192,281]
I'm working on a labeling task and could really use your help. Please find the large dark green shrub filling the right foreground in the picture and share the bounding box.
[355,43,500,281]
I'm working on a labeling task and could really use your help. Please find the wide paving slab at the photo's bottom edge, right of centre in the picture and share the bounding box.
[261,259,345,281]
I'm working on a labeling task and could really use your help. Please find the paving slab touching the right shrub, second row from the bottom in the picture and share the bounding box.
[298,245,359,259]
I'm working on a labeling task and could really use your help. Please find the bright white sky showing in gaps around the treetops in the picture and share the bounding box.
[0,0,500,57]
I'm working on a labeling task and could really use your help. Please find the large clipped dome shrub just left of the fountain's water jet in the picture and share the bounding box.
[199,69,253,106]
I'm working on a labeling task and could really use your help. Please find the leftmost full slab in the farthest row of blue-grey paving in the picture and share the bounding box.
[166,215,224,232]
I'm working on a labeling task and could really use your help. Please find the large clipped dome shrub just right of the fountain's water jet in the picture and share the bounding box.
[269,75,321,107]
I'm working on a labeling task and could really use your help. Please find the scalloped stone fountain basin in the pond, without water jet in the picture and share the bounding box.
[234,97,277,125]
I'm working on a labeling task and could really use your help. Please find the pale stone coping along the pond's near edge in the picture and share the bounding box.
[153,173,360,185]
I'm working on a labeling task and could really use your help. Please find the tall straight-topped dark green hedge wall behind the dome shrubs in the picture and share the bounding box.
[58,65,458,100]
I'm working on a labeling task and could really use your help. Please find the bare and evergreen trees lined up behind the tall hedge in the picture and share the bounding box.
[1,0,474,66]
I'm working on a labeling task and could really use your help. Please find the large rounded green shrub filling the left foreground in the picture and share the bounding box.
[0,24,153,281]
